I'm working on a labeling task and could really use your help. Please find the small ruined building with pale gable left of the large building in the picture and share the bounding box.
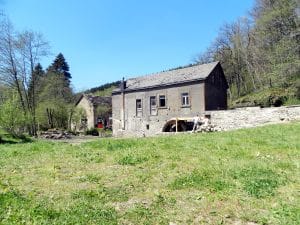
[72,94,112,131]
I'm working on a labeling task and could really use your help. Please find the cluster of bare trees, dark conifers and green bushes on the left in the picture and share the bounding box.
[0,13,81,136]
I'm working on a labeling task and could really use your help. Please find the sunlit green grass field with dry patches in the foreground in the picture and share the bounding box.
[0,122,300,225]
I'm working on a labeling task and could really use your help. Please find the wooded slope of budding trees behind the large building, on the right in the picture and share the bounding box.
[196,0,300,105]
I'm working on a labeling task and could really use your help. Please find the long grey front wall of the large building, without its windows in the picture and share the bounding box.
[112,82,205,137]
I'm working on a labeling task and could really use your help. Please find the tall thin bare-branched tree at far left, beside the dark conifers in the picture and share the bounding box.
[0,15,49,135]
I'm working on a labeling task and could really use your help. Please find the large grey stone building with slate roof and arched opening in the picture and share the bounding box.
[112,62,228,136]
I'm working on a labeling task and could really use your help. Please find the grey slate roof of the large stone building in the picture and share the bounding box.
[113,62,219,93]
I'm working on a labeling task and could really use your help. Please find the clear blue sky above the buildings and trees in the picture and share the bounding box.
[0,0,254,91]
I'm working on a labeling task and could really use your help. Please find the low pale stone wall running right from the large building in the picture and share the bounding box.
[206,105,300,130]
